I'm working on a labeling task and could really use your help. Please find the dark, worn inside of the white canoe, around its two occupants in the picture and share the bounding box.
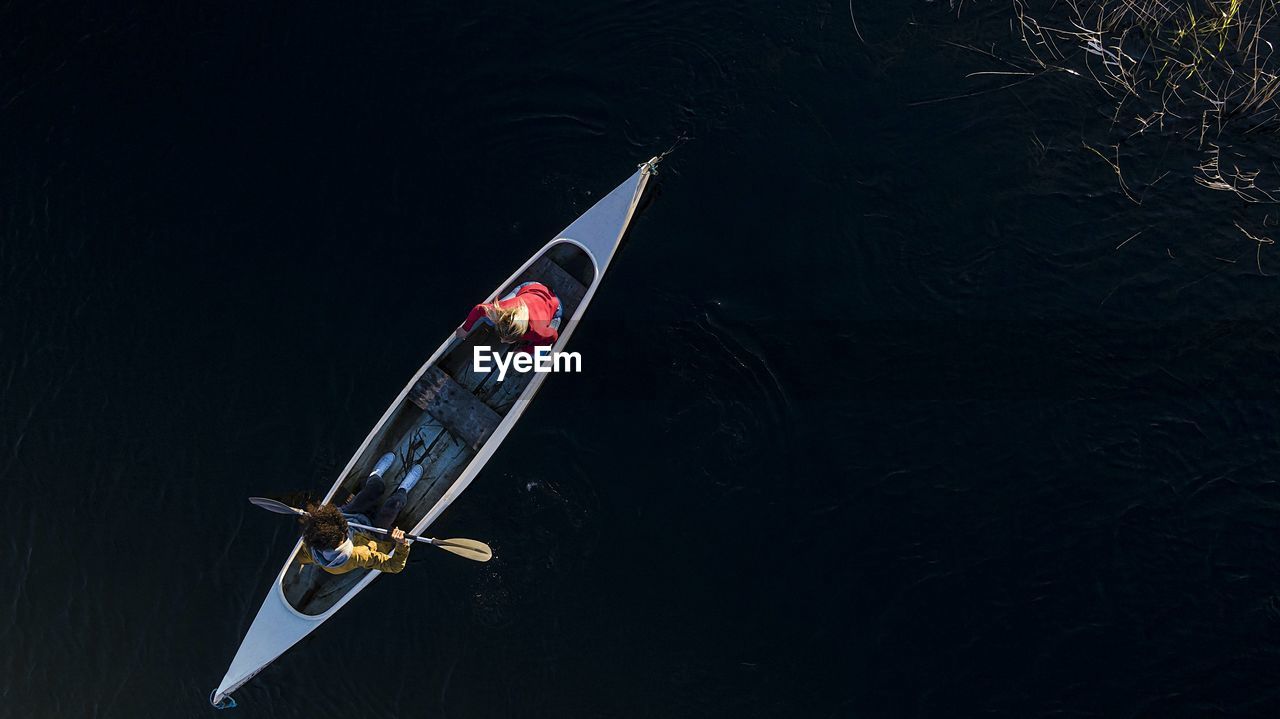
[283,242,595,615]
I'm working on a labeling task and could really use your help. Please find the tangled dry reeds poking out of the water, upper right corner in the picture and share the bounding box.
[967,0,1280,262]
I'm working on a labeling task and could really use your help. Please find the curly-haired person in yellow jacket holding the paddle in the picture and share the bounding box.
[298,453,422,574]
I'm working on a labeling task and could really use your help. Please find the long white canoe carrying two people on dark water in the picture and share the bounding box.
[210,157,659,706]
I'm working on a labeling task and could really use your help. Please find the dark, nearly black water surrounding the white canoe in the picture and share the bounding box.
[0,0,1280,718]
